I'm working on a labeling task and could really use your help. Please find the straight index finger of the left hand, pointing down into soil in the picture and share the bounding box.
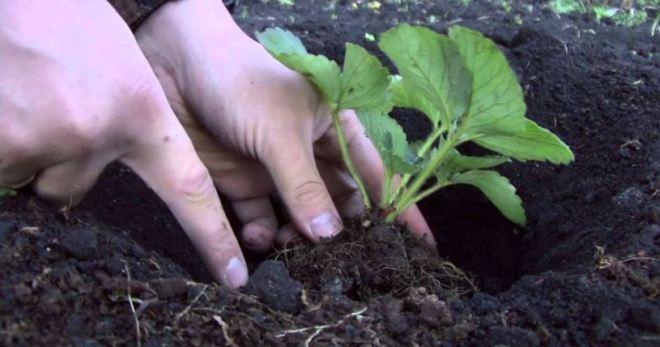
[123,111,248,288]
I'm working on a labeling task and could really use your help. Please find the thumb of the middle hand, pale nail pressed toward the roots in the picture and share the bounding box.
[262,135,341,242]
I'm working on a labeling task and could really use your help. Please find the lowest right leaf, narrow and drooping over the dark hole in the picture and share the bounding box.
[452,170,527,225]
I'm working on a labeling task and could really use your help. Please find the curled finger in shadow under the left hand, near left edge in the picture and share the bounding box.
[33,159,111,207]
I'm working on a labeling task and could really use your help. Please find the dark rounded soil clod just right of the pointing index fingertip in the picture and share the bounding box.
[245,260,302,313]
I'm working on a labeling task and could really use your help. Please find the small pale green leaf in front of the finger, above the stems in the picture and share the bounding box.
[358,111,419,174]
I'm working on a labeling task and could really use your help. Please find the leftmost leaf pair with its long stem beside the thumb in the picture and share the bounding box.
[256,28,392,209]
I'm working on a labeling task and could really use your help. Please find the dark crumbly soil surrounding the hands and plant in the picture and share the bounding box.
[0,0,660,346]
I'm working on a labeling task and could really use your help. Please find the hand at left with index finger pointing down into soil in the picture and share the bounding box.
[0,0,247,288]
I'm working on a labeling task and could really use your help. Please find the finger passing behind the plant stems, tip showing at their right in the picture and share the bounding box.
[318,110,435,244]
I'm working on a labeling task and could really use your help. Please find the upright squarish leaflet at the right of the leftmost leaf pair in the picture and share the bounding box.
[338,43,392,113]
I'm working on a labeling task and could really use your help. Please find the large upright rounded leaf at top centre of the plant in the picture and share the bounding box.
[379,24,472,126]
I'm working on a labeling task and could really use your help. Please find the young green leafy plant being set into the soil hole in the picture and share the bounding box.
[255,24,574,225]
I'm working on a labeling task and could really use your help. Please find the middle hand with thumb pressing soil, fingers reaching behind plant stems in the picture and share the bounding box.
[136,0,434,251]
